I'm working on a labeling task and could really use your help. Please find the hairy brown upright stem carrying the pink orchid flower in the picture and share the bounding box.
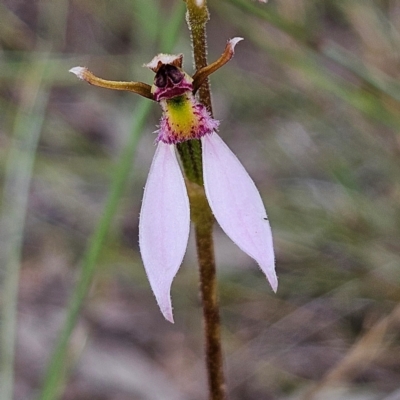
[184,0,226,400]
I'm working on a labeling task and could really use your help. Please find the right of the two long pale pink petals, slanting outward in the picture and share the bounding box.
[201,133,278,291]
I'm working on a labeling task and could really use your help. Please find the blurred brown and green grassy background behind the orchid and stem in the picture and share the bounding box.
[0,0,400,400]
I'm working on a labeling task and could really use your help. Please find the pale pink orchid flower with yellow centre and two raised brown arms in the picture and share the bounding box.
[70,38,278,322]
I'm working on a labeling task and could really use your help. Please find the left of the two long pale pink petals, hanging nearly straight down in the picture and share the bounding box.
[139,142,190,322]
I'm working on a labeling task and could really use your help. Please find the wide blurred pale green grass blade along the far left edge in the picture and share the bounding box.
[0,52,48,400]
